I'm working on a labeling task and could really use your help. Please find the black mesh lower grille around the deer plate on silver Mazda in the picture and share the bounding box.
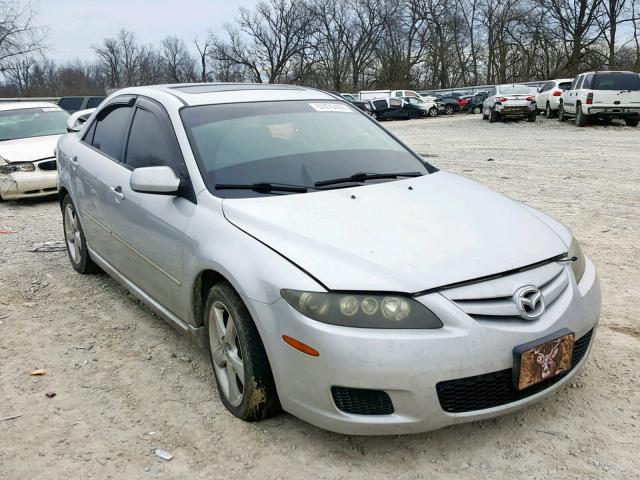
[436,330,593,413]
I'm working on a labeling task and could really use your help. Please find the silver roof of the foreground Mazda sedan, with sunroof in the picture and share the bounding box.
[117,83,343,106]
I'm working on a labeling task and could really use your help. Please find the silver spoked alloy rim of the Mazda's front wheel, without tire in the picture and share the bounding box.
[209,300,245,407]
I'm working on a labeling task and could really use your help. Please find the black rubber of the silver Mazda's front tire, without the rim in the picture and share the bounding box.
[204,282,281,422]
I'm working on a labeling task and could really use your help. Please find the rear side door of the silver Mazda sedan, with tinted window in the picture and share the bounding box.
[69,96,135,263]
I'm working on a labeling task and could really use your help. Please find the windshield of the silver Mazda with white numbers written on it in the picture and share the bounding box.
[181,100,435,198]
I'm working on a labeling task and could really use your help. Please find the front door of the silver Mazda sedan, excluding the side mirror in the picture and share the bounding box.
[106,97,196,318]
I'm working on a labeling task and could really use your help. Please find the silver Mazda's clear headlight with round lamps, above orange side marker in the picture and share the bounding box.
[280,290,442,329]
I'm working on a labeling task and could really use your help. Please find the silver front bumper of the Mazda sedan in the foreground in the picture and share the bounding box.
[247,260,601,435]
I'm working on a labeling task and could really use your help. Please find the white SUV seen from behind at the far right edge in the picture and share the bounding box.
[558,72,640,127]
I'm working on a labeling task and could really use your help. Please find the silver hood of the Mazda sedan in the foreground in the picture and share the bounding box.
[223,172,567,293]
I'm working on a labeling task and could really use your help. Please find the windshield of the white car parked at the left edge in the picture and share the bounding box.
[0,106,69,141]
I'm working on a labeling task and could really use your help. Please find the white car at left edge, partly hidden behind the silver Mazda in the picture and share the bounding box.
[0,102,69,200]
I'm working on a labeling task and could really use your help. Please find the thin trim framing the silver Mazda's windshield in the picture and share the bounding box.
[178,98,440,200]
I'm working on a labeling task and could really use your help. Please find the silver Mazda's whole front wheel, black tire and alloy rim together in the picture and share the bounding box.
[205,282,280,422]
